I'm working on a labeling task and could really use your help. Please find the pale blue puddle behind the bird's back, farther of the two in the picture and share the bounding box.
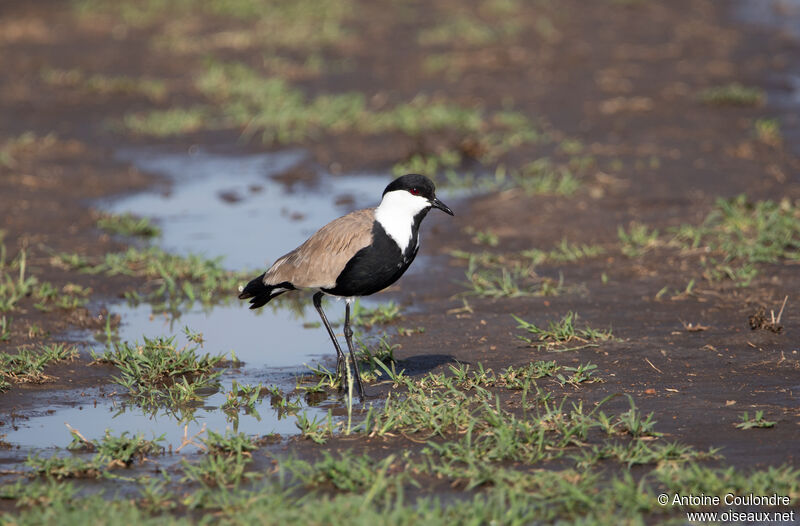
[103,150,391,270]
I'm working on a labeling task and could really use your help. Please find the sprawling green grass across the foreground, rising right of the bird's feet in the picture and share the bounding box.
[0,362,800,525]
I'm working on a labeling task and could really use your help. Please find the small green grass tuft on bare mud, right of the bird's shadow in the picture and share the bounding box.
[511,311,613,352]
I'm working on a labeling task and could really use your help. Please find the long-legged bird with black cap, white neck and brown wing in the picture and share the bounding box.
[239,174,455,400]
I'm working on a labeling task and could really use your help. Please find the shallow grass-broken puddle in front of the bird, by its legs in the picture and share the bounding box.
[5,301,350,452]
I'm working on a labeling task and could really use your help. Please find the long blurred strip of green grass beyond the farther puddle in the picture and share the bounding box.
[125,62,483,144]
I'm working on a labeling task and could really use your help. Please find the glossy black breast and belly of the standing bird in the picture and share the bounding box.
[322,221,419,297]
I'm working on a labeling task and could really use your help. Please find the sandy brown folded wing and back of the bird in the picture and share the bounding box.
[264,208,375,289]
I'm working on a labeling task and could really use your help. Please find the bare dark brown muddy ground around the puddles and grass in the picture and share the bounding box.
[0,0,800,520]
